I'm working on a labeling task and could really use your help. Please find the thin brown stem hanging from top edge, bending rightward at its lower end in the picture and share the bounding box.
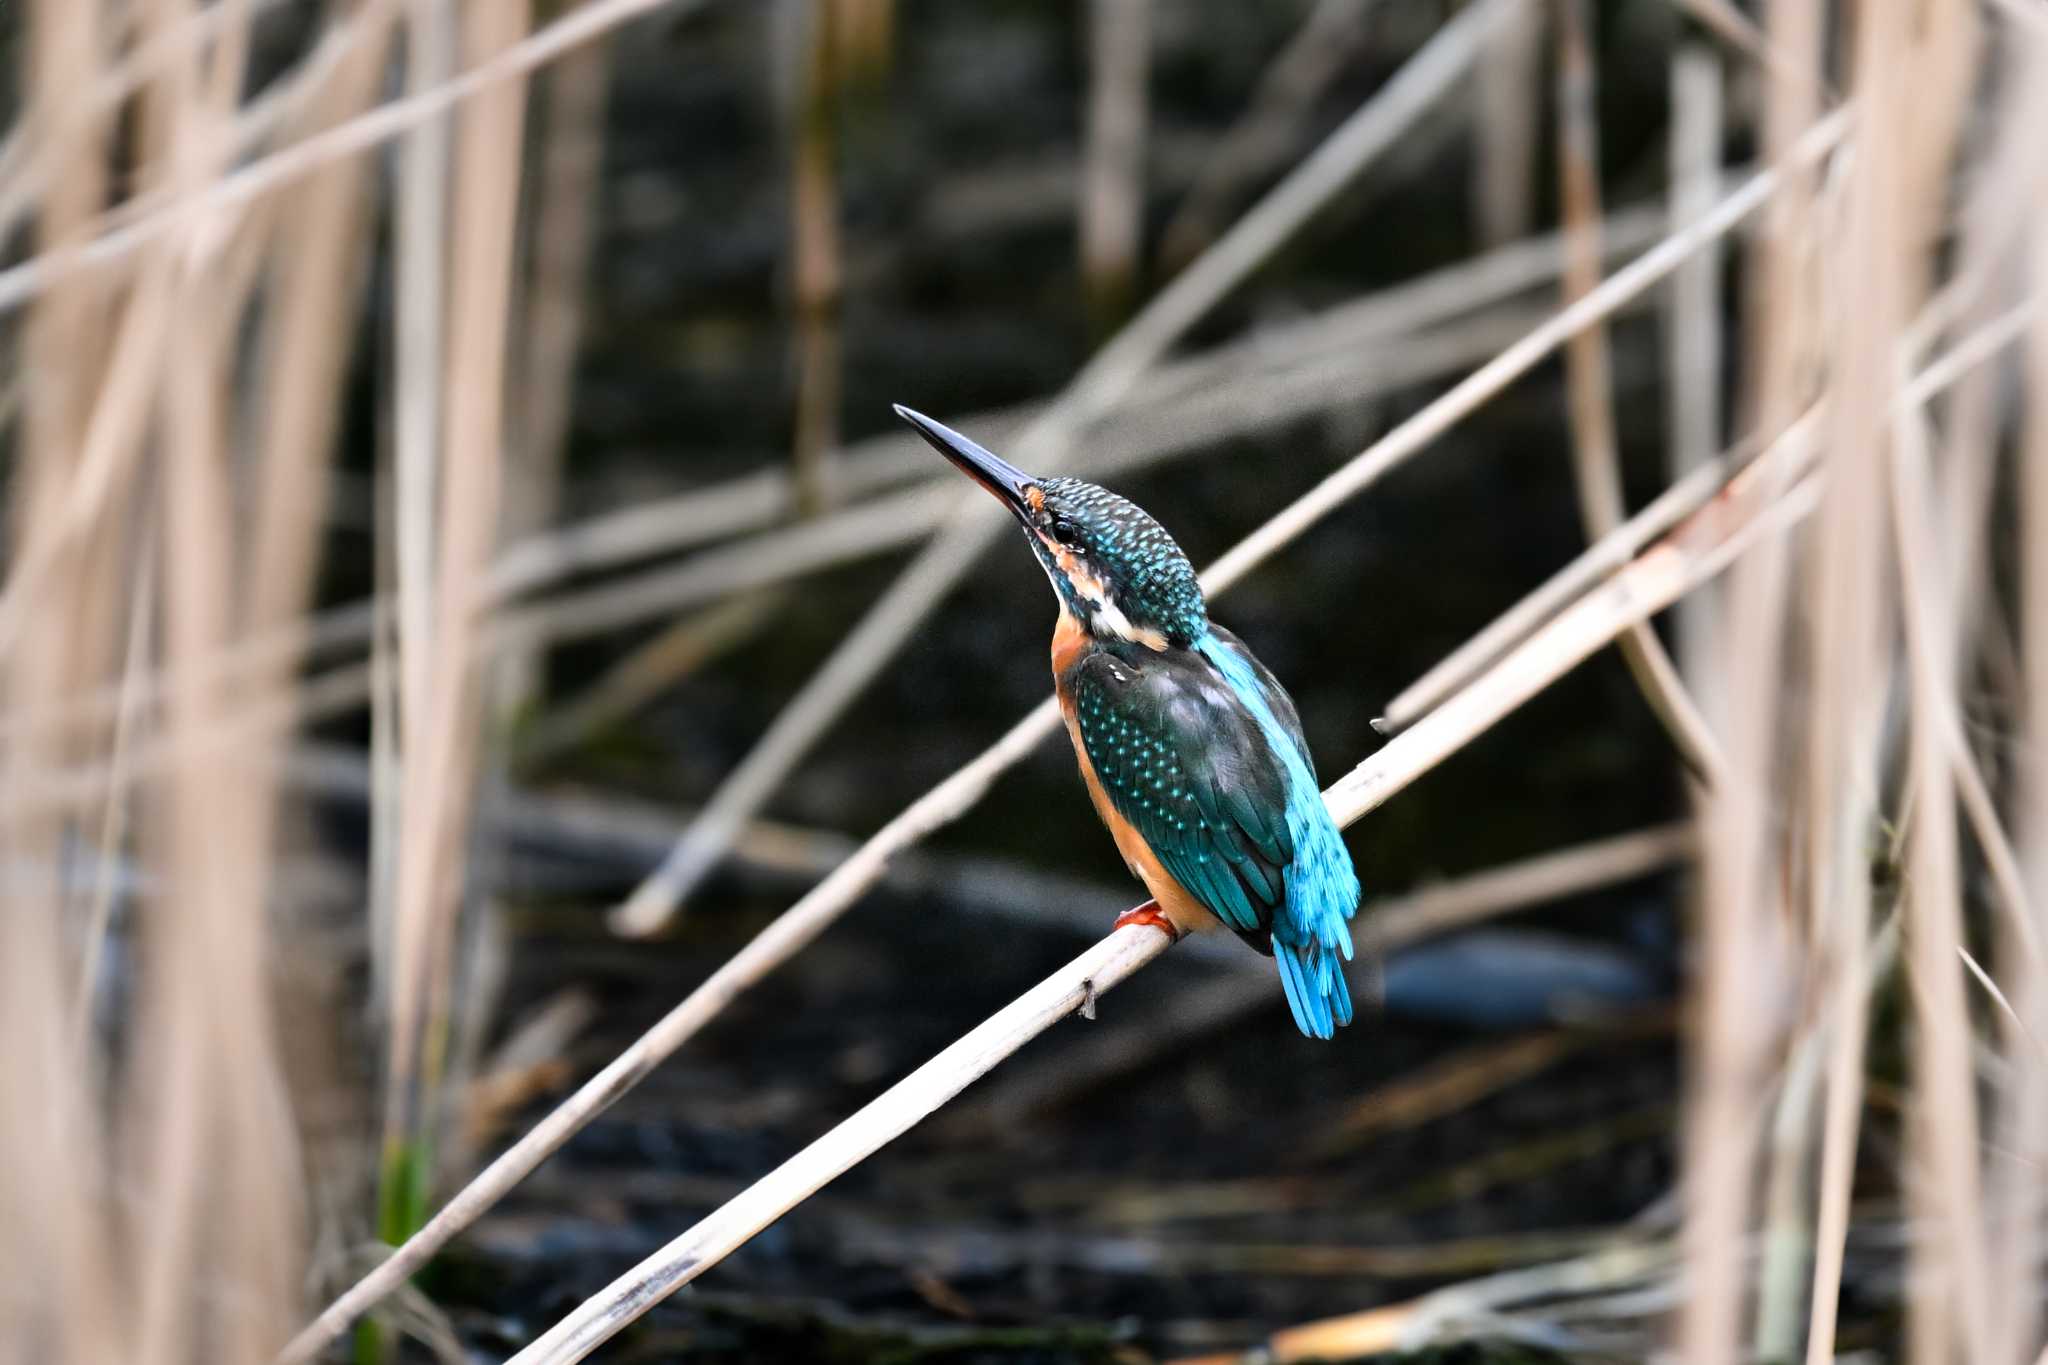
[1552,0,1726,786]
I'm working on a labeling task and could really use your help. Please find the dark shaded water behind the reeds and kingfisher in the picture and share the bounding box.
[360,0,1703,1361]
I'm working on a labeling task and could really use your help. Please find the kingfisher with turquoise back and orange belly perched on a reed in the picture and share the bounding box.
[895,403,1360,1038]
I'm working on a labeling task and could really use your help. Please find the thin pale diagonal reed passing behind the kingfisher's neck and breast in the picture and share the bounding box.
[283,115,1847,1361]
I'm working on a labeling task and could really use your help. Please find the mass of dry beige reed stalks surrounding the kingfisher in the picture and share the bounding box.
[0,0,2048,1365]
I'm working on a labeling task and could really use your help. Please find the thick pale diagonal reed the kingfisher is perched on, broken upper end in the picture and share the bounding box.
[510,423,1812,1365]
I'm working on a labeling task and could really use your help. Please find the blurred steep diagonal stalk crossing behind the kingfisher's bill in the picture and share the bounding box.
[610,0,1518,935]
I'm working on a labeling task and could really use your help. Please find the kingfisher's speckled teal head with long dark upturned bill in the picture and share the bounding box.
[895,405,1208,649]
